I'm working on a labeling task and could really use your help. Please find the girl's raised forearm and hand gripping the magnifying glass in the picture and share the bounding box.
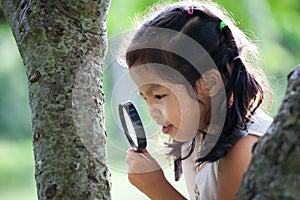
[126,149,185,200]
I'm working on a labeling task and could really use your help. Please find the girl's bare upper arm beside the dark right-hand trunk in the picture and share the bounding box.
[217,135,258,200]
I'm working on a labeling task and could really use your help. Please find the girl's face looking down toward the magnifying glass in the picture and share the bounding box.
[130,66,210,142]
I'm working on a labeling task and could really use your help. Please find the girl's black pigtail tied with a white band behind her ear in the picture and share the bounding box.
[222,26,263,125]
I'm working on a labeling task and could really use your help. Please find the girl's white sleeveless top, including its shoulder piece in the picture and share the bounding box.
[182,110,272,200]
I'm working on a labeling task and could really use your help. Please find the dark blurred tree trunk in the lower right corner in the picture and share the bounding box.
[236,65,300,200]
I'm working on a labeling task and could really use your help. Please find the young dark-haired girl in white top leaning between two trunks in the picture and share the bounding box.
[126,2,272,200]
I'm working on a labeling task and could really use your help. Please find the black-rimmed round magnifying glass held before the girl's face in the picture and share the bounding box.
[119,101,147,153]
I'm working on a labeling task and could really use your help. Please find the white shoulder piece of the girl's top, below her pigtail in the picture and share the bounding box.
[247,109,273,137]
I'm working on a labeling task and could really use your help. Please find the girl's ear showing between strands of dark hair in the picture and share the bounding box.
[195,69,224,99]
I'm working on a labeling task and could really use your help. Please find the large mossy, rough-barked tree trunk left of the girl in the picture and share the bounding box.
[0,0,111,200]
